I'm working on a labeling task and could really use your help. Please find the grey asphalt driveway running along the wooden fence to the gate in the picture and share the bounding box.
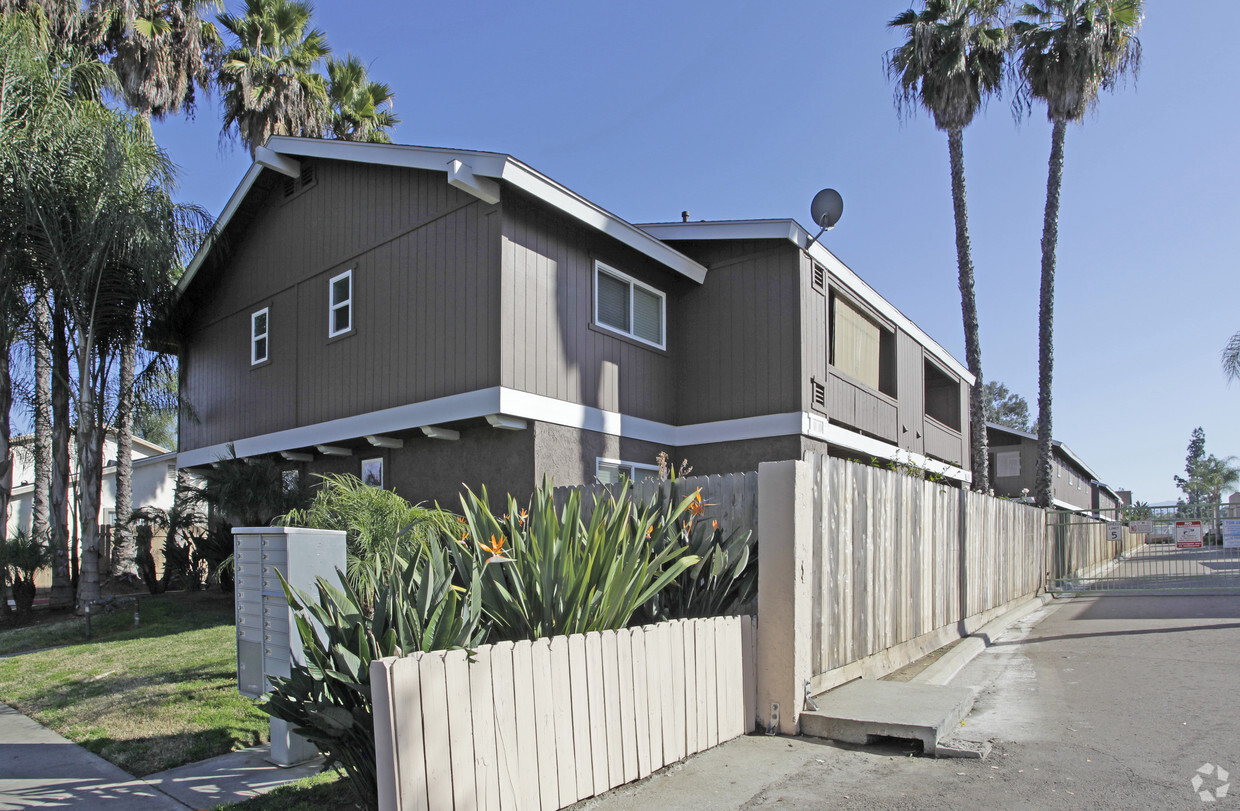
[583,595,1240,811]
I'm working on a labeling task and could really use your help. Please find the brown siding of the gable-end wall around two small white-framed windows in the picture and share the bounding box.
[181,161,500,449]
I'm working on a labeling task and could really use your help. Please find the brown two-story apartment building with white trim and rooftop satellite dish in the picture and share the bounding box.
[169,138,973,502]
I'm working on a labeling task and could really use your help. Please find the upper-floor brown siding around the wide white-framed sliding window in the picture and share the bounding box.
[498,192,693,423]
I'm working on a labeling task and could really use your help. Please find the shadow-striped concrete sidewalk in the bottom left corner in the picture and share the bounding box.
[0,704,321,811]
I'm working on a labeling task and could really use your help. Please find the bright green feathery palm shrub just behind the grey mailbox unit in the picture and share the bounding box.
[277,475,439,594]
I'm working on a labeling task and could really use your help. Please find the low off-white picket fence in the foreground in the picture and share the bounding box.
[371,616,755,811]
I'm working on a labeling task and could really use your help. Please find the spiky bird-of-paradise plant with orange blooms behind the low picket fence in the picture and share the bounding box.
[443,479,698,640]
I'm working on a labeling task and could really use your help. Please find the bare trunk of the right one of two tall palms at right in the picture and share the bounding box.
[1034,120,1068,507]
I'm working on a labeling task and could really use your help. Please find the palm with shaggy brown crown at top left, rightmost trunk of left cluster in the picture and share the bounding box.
[91,0,223,579]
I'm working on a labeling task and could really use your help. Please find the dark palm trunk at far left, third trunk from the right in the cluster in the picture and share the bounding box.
[48,301,73,609]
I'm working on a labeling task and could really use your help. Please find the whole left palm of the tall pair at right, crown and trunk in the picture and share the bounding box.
[885,0,1008,490]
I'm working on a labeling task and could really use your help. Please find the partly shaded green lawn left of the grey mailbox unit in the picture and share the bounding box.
[0,592,267,776]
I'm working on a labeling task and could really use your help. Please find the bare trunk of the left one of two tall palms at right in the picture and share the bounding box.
[947,128,991,491]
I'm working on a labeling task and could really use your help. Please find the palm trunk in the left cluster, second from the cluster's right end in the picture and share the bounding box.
[77,329,103,614]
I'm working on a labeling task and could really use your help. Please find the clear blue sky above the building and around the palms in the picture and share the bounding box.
[147,0,1240,501]
